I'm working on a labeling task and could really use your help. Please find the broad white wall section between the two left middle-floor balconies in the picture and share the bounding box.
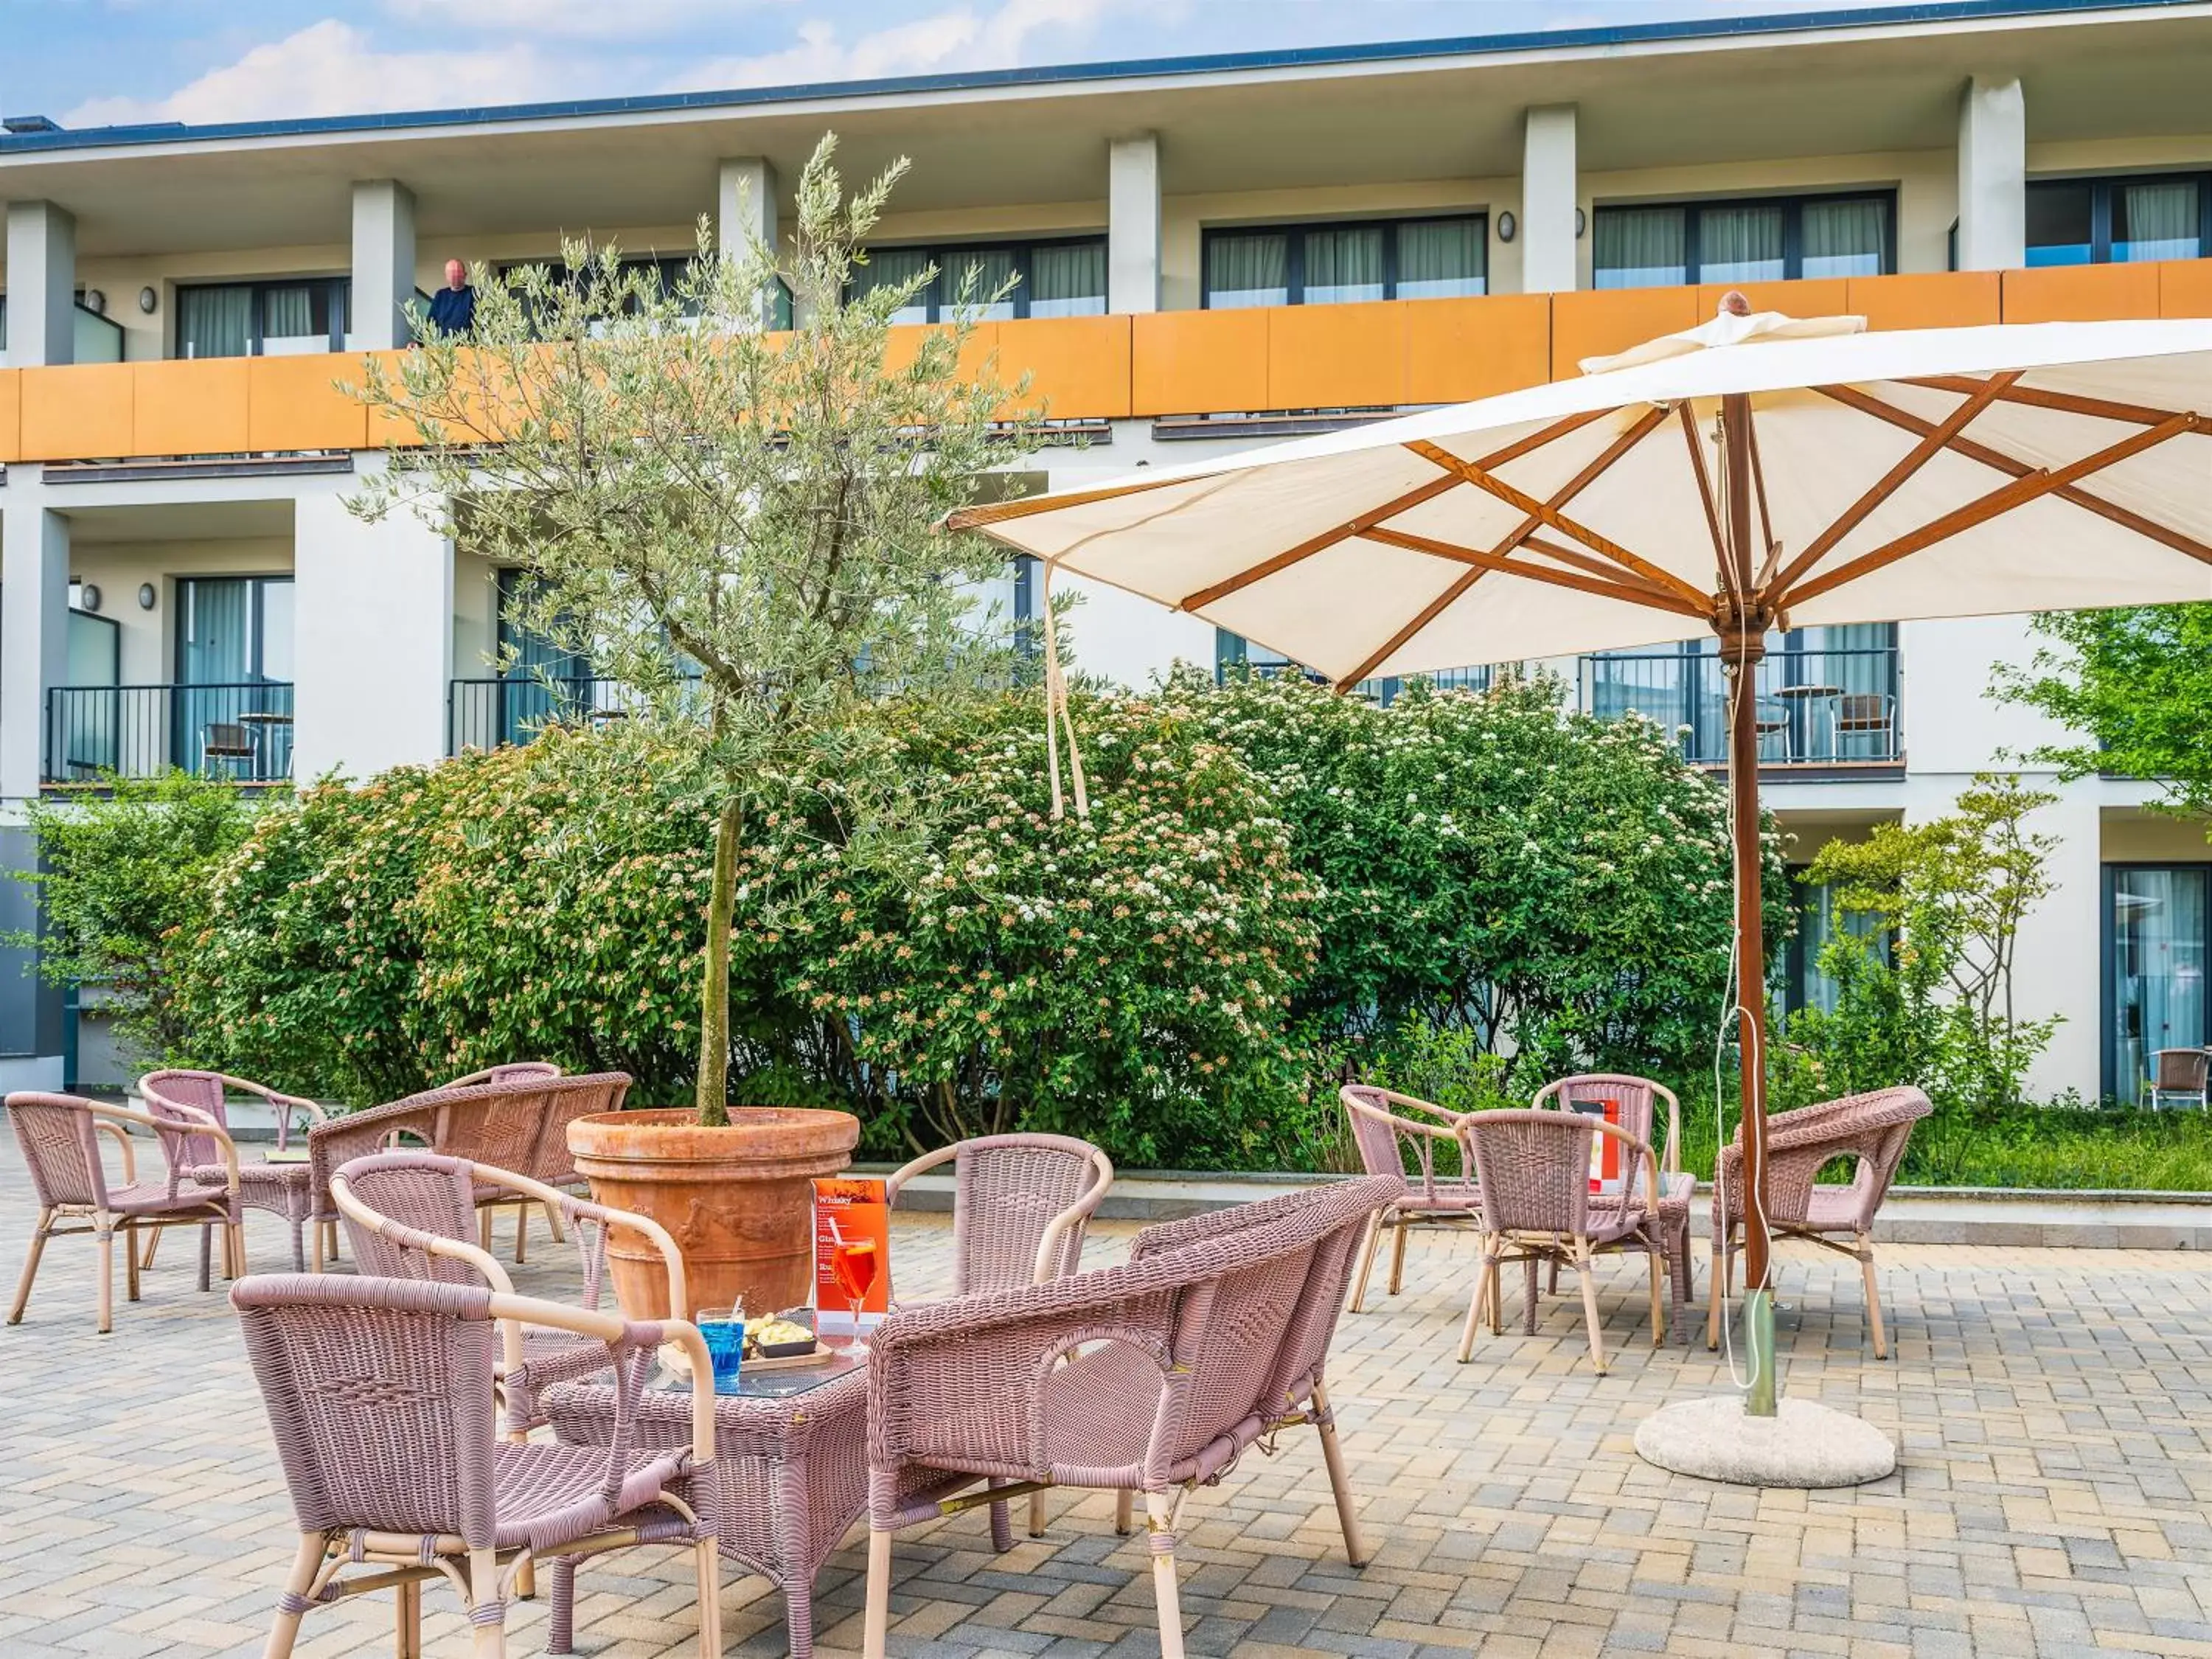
[292,469,453,779]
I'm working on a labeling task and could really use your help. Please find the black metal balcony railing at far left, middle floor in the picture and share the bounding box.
[44,679,292,783]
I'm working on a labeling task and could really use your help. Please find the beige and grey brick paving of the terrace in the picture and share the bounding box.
[0,1144,2212,1659]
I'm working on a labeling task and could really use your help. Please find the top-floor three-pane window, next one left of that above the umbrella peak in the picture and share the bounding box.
[1203,212,1489,312]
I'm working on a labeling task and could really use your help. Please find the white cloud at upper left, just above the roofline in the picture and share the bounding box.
[64,18,604,126]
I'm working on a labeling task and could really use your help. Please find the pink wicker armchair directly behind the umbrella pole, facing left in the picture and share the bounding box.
[1705,1088,1933,1360]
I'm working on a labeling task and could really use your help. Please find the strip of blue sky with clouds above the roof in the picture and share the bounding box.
[0,0,1885,126]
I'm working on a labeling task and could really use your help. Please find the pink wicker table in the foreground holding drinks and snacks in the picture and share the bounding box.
[542,1356,867,1659]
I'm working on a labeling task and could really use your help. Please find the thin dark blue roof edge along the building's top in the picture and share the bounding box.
[0,0,2201,155]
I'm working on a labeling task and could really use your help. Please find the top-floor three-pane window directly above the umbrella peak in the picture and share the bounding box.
[1593,190,1896,288]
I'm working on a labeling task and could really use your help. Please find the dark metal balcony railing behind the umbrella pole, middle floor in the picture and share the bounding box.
[1582,646,1905,768]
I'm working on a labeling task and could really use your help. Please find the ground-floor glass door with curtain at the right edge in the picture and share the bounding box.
[2104,865,2212,1104]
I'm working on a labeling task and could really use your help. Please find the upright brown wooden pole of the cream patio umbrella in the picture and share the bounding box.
[1714,394,1776,1418]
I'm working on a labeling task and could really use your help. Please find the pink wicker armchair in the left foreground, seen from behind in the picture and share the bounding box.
[230,1274,721,1659]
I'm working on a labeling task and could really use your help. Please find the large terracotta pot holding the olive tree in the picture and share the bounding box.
[568,1106,860,1318]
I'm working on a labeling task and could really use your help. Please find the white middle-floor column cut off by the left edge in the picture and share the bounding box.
[0,478,69,801]
